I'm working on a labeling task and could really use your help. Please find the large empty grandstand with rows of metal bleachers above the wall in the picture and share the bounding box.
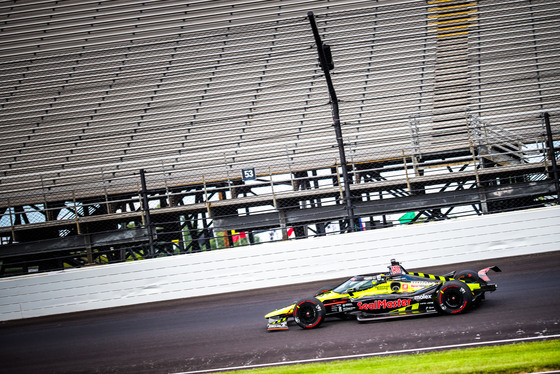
[0,0,560,275]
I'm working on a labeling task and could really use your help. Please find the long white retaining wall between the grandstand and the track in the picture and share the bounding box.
[0,207,560,321]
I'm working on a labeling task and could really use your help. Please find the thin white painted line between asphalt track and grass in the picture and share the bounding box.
[174,334,560,374]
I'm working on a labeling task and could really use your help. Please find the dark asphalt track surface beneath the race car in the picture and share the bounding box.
[0,251,560,373]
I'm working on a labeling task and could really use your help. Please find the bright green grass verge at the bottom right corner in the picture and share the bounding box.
[224,340,560,374]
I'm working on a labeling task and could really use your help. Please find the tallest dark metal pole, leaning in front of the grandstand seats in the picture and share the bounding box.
[307,12,355,232]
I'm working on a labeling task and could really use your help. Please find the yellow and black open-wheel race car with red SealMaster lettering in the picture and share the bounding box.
[265,260,501,331]
